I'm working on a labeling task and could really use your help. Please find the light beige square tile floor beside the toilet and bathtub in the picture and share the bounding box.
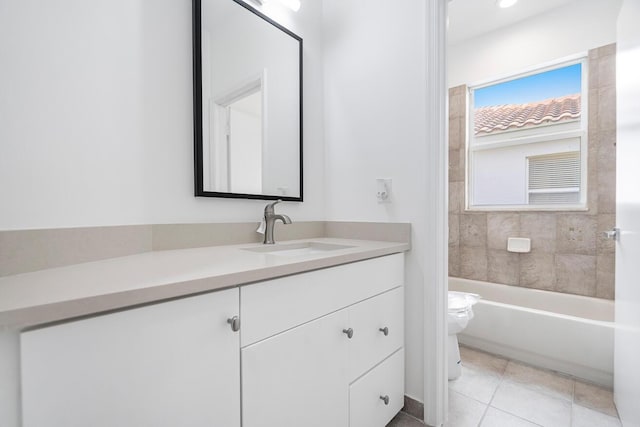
[387,347,622,427]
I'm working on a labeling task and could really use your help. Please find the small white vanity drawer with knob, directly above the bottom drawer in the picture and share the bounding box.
[348,287,404,381]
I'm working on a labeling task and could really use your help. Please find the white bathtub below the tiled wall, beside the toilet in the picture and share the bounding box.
[449,277,614,387]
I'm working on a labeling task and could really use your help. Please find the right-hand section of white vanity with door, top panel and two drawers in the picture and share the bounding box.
[241,254,404,427]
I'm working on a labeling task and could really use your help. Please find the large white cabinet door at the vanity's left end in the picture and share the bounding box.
[21,289,240,427]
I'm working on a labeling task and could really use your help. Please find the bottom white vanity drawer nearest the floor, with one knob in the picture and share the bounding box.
[349,349,404,427]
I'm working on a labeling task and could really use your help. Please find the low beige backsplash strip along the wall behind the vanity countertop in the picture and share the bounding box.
[0,221,412,278]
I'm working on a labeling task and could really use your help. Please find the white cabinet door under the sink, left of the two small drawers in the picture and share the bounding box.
[242,310,349,427]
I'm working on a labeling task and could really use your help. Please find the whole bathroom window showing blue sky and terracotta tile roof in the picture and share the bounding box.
[467,59,587,210]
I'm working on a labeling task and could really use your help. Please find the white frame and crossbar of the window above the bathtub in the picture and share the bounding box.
[465,53,589,212]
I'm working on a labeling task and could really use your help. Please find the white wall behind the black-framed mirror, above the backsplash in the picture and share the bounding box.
[0,0,324,230]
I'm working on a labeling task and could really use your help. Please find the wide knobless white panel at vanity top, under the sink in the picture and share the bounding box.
[240,254,404,347]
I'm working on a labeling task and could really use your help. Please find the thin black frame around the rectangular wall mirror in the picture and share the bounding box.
[192,0,304,202]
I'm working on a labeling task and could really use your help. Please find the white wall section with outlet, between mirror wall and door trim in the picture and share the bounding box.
[324,0,427,400]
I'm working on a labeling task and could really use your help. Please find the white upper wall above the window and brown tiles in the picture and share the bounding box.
[448,0,622,87]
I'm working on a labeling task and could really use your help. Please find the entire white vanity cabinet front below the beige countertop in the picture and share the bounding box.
[20,253,404,427]
